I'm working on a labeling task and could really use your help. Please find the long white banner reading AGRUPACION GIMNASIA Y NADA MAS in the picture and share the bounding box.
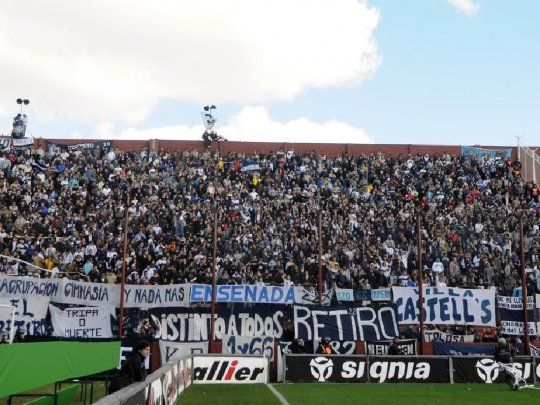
[0,275,189,308]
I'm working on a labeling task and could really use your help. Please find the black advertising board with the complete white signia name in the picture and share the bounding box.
[285,355,450,383]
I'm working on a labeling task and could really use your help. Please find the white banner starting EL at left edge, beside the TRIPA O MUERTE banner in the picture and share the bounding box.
[0,297,49,336]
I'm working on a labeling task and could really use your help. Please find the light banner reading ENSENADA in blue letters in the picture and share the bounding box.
[189,284,295,304]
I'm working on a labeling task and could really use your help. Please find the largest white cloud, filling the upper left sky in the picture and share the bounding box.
[0,0,381,126]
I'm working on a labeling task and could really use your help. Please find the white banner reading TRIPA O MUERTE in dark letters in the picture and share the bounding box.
[49,305,115,339]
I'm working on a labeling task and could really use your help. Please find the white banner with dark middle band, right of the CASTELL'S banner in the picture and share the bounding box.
[497,295,538,336]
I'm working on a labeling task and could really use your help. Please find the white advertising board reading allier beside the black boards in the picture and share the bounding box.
[192,355,268,384]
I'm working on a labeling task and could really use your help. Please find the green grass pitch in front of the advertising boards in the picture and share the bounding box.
[179,383,540,405]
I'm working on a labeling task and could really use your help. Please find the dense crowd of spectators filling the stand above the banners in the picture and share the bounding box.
[0,142,540,295]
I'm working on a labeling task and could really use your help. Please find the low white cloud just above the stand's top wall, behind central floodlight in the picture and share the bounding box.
[109,106,373,143]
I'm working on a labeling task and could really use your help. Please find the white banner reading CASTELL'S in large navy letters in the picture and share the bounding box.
[392,287,495,326]
